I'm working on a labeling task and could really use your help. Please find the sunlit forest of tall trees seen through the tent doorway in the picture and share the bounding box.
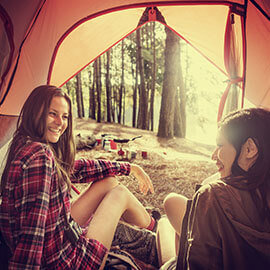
[63,22,239,143]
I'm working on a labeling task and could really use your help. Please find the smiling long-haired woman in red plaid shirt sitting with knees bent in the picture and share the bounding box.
[0,85,154,269]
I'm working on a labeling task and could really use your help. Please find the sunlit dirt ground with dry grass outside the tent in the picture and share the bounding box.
[75,119,216,213]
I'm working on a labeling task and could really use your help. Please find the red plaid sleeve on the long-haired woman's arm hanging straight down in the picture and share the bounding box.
[9,148,53,270]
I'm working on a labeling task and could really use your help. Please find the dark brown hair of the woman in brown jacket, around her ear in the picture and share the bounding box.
[219,108,270,221]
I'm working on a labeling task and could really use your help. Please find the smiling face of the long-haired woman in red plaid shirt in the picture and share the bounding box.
[46,96,70,143]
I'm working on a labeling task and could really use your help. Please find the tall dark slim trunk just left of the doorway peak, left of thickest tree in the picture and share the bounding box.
[136,28,148,129]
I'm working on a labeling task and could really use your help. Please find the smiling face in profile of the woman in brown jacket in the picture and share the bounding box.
[212,132,236,178]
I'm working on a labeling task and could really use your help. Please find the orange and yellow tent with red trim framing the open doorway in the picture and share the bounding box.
[0,0,270,152]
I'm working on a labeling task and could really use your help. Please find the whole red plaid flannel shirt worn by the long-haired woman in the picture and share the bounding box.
[0,138,130,270]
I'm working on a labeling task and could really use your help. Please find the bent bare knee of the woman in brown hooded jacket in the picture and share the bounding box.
[163,193,187,254]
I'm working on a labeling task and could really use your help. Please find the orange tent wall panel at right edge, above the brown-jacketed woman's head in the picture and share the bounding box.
[245,1,270,108]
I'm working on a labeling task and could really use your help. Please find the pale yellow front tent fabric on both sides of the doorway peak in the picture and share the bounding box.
[50,6,228,85]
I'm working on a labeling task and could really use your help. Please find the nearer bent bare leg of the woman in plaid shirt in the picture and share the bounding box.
[87,185,150,269]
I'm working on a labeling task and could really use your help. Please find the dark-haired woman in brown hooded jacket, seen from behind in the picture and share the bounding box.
[164,108,270,270]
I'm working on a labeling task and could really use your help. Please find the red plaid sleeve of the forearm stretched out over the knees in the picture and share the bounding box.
[72,159,130,183]
